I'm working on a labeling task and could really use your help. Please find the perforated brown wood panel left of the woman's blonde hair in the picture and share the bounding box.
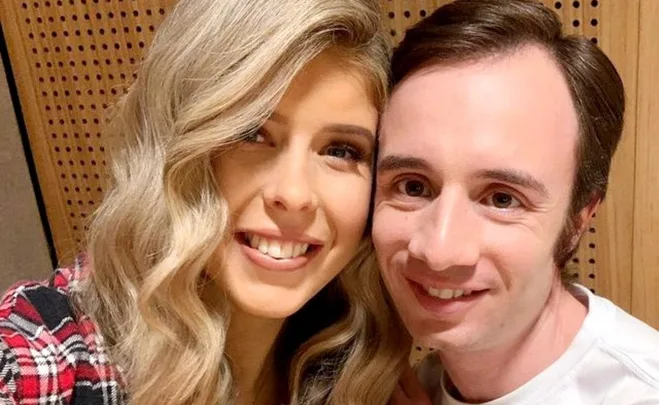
[3,0,177,262]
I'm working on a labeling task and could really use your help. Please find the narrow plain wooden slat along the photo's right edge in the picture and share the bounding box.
[632,0,659,328]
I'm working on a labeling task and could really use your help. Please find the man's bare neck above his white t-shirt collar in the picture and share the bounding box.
[440,284,588,403]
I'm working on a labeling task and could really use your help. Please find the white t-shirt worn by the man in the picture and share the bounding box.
[417,286,659,405]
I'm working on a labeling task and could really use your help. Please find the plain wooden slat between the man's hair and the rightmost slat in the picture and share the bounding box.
[592,0,639,311]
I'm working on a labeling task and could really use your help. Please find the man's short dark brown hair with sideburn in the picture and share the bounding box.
[392,0,625,276]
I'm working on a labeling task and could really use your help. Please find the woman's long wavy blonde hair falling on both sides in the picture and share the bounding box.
[78,0,408,405]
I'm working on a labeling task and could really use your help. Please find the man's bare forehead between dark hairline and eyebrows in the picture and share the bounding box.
[379,44,578,189]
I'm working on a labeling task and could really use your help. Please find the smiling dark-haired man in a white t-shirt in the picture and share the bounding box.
[373,0,659,405]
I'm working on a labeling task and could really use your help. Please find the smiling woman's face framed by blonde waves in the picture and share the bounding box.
[214,54,378,319]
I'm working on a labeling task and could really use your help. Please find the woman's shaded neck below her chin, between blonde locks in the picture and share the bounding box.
[225,310,284,405]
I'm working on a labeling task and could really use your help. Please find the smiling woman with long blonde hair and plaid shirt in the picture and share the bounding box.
[0,0,407,405]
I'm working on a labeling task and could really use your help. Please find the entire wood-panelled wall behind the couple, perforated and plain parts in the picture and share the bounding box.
[0,0,659,342]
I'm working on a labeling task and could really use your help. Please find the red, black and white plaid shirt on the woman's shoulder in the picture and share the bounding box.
[0,261,126,405]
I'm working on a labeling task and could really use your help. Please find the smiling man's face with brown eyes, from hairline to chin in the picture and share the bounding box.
[373,46,578,350]
